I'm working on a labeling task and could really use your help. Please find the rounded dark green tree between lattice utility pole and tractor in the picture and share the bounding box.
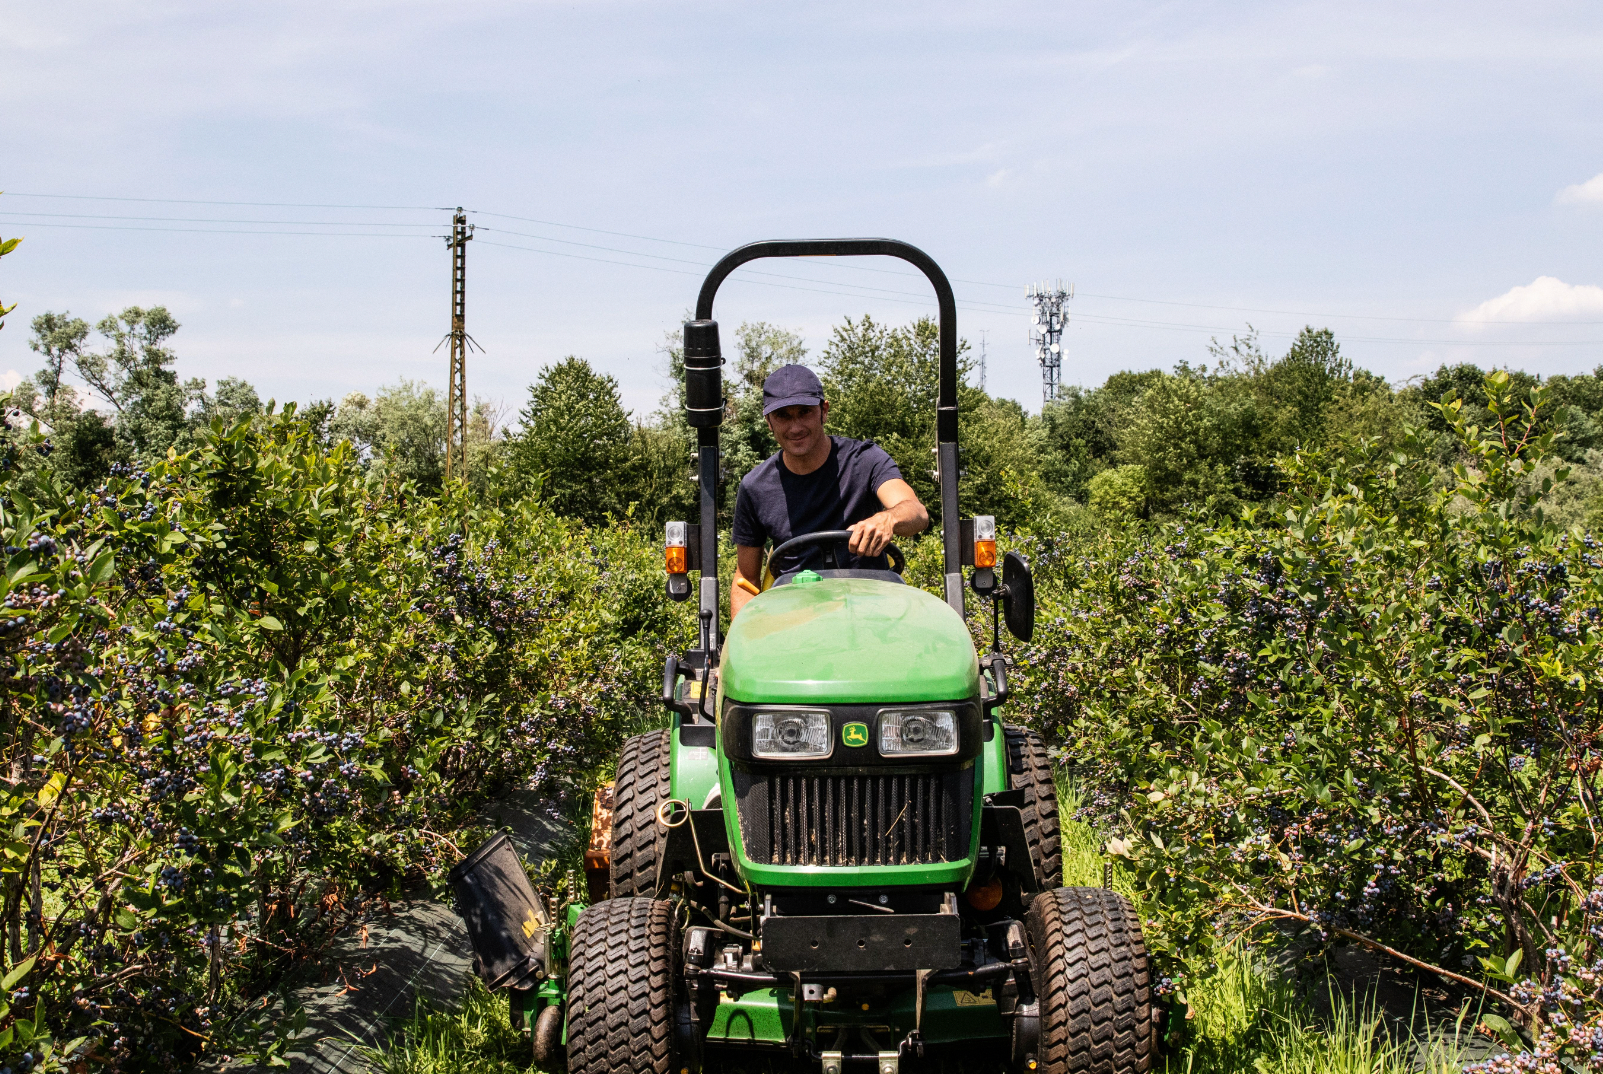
[510,354,630,523]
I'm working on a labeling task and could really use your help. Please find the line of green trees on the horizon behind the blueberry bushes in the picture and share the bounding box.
[25,306,1603,541]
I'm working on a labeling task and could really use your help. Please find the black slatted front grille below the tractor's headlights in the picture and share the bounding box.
[734,768,975,866]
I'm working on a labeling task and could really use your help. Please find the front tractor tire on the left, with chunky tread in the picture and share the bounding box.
[567,898,680,1074]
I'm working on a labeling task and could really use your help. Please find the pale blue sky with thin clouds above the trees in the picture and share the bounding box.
[0,0,1603,415]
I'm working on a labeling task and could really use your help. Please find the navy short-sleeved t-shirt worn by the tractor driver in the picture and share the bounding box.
[734,436,901,575]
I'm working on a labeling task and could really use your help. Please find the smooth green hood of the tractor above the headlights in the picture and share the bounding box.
[720,579,979,704]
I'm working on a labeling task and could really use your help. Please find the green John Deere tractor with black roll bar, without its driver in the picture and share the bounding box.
[455,239,1156,1074]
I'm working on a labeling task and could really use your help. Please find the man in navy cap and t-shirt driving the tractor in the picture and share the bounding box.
[729,365,930,617]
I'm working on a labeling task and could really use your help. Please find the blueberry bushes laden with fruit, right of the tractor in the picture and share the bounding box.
[1020,373,1603,1072]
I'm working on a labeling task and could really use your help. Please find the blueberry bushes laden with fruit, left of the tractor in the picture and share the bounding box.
[0,407,683,1071]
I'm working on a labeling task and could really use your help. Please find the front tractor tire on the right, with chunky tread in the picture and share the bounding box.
[1024,888,1153,1074]
